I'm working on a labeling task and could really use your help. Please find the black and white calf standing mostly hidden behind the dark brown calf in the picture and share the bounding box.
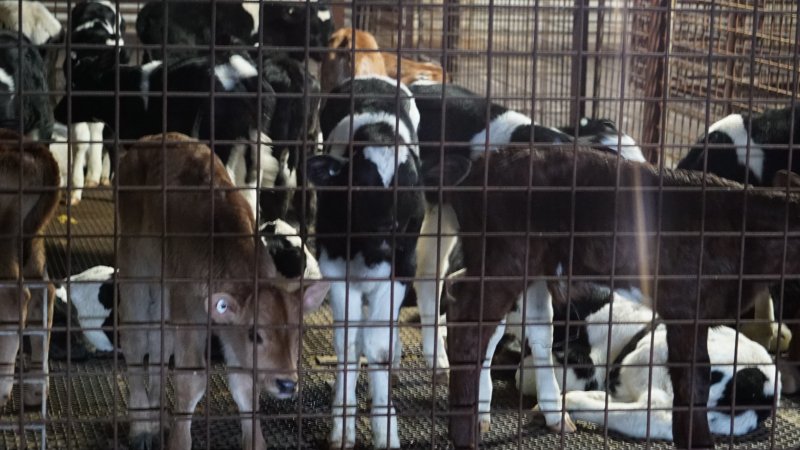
[409,82,644,380]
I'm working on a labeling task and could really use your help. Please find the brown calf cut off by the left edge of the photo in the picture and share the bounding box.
[0,130,59,407]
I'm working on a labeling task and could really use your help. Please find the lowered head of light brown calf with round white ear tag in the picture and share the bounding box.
[206,248,330,398]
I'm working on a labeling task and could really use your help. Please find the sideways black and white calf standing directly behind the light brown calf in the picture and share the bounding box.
[55,53,279,217]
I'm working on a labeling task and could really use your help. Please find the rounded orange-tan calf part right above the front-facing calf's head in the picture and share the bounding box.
[319,28,387,92]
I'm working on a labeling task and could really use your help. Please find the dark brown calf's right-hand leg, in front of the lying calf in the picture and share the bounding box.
[662,322,714,448]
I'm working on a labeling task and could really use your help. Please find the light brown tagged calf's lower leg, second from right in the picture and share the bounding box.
[167,329,206,450]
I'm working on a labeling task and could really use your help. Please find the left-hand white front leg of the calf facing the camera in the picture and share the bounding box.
[328,282,362,449]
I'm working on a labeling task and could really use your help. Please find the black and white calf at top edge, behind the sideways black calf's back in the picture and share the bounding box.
[136,0,333,61]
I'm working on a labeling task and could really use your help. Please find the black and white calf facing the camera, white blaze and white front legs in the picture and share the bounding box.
[308,77,425,448]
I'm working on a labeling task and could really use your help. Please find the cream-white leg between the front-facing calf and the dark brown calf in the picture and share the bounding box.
[414,205,458,376]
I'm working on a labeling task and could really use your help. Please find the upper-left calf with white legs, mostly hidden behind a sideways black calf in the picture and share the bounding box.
[62,0,130,205]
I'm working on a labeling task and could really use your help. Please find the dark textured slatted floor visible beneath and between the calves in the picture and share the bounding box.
[0,188,800,450]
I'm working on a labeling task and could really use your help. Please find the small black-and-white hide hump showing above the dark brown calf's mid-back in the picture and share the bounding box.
[558,117,647,162]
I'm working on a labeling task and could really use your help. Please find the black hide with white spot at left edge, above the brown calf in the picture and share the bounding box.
[0,31,53,141]
